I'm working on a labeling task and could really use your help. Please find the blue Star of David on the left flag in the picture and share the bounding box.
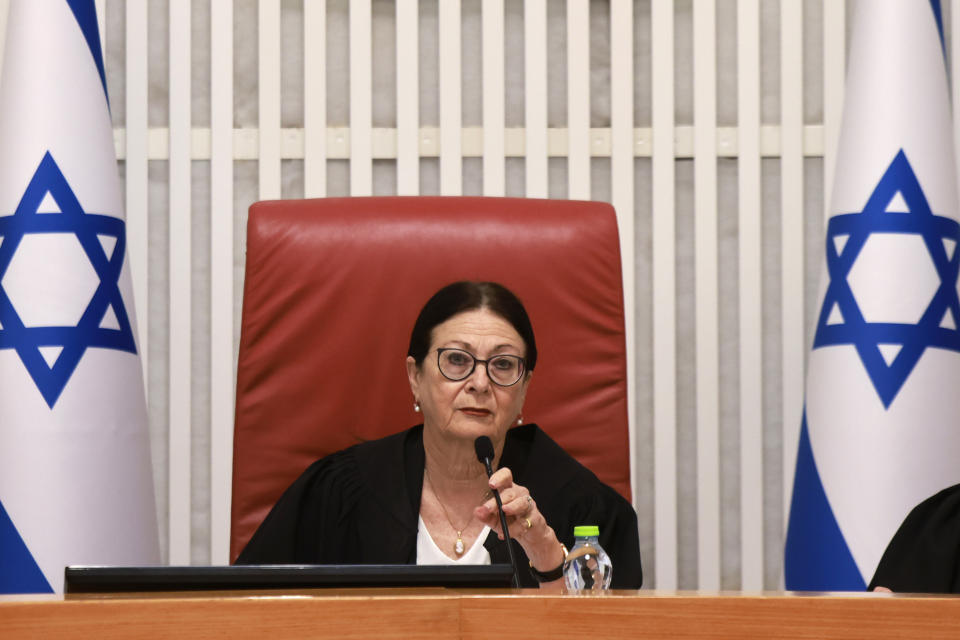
[0,152,137,409]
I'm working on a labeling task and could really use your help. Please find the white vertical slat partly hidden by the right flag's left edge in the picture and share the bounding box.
[823,0,846,220]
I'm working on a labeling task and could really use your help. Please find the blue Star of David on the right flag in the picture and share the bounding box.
[813,150,960,408]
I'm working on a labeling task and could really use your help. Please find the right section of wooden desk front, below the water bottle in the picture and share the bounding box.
[460,592,960,640]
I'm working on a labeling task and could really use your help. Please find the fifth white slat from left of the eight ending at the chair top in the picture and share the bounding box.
[438,0,463,196]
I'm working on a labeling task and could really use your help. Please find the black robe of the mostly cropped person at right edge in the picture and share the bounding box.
[868,484,960,593]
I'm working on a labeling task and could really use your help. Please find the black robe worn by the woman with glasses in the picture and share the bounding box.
[237,424,643,589]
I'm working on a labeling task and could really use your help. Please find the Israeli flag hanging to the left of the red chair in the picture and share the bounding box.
[0,0,159,593]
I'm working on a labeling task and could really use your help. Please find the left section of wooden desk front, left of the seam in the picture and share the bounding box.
[0,590,459,640]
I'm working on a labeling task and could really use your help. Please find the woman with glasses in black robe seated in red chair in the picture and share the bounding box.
[237,282,643,588]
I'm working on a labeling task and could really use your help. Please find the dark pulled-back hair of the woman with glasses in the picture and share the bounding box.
[407,280,537,371]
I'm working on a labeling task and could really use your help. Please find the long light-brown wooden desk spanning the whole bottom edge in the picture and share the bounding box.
[0,588,960,640]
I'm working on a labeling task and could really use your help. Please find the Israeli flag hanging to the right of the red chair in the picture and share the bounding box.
[785,0,960,590]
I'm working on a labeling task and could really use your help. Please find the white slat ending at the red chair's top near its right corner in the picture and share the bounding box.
[567,0,590,200]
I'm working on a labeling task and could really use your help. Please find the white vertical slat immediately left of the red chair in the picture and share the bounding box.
[210,2,236,564]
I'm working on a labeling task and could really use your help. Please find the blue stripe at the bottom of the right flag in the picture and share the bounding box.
[784,412,867,591]
